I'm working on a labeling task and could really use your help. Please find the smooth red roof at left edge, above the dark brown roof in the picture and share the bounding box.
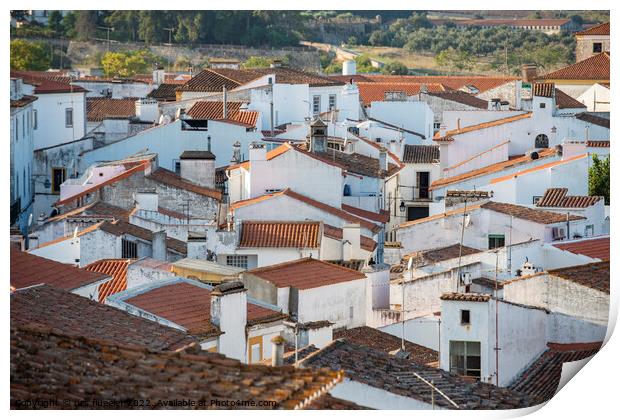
[10,248,110,290]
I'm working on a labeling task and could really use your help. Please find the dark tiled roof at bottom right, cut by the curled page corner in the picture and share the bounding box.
[509,342,603,404]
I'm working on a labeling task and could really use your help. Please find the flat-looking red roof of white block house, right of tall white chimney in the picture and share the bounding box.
[246,258,366,290]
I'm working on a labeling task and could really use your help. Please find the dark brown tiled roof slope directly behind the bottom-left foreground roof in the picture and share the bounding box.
[11,286,197,350]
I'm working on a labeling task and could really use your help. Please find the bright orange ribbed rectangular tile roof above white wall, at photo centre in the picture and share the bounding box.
[238,220,321,248]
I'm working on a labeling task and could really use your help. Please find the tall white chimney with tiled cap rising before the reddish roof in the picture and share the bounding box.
[211,281,247,362]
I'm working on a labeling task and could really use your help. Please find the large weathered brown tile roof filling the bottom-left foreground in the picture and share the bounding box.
[11,327,342,409]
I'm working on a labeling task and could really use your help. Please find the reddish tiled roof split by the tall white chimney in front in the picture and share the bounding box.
[125,282,285,338]
